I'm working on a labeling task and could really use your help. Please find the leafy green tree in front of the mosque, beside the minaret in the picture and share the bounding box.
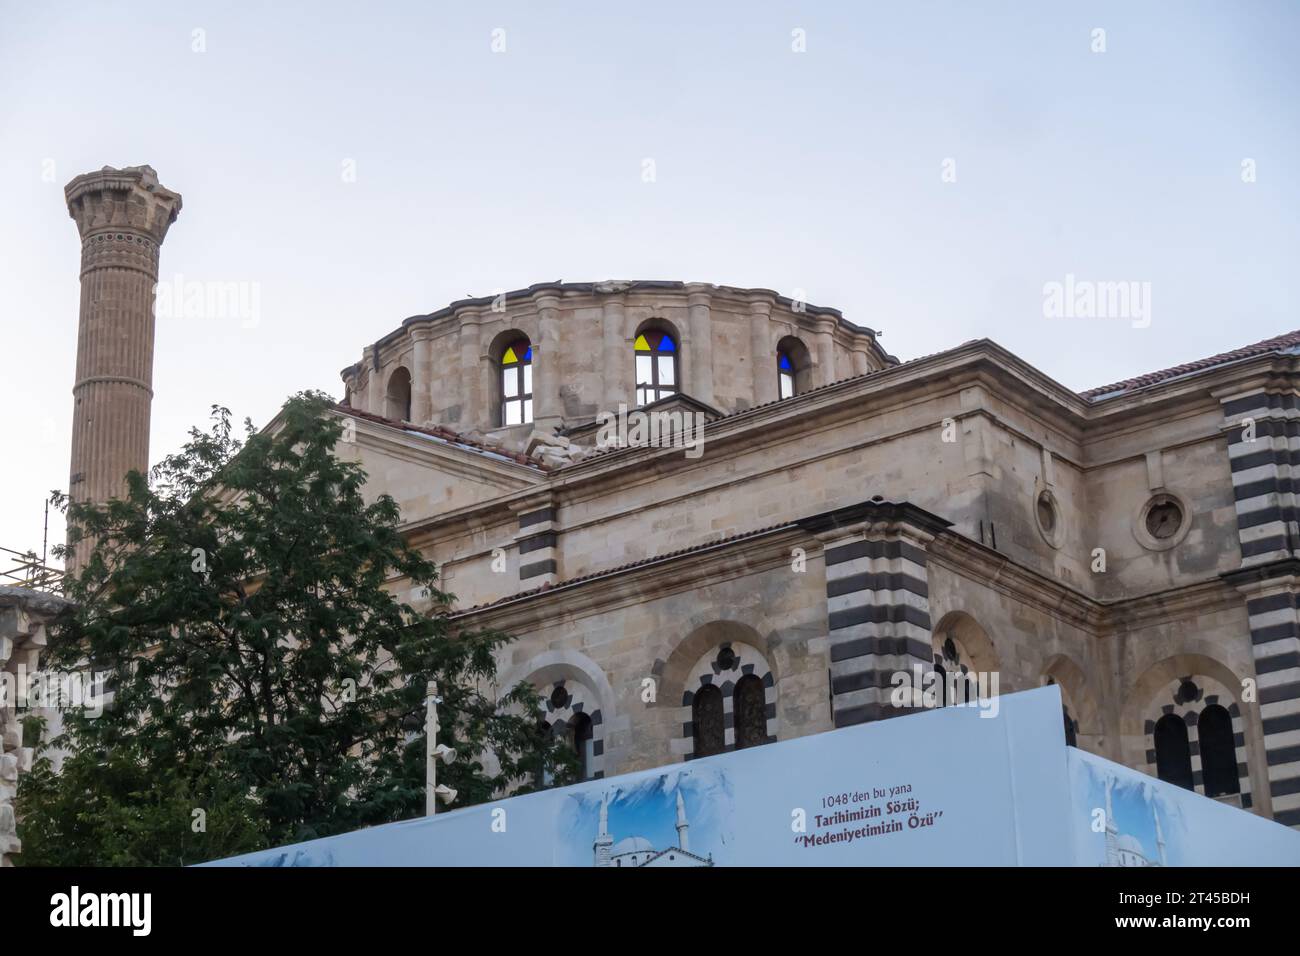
[17,393,576,865]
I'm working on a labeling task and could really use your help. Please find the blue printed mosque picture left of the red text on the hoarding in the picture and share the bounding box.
[558,767,732,869]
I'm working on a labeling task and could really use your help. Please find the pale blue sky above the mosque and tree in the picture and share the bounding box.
[0,0,1300,561]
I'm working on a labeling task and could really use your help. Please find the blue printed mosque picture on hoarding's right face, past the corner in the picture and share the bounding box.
[1075,763,1187,866]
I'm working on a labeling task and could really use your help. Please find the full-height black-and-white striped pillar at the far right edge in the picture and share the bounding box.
[1223,390,1300,826]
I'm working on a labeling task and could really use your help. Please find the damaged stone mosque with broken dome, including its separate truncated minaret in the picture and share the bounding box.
[7,166,1300,868]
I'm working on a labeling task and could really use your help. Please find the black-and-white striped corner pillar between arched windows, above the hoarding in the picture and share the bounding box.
[824,528,932,727]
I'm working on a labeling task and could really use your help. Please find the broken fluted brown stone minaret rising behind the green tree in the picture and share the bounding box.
[64,166,181,570]
